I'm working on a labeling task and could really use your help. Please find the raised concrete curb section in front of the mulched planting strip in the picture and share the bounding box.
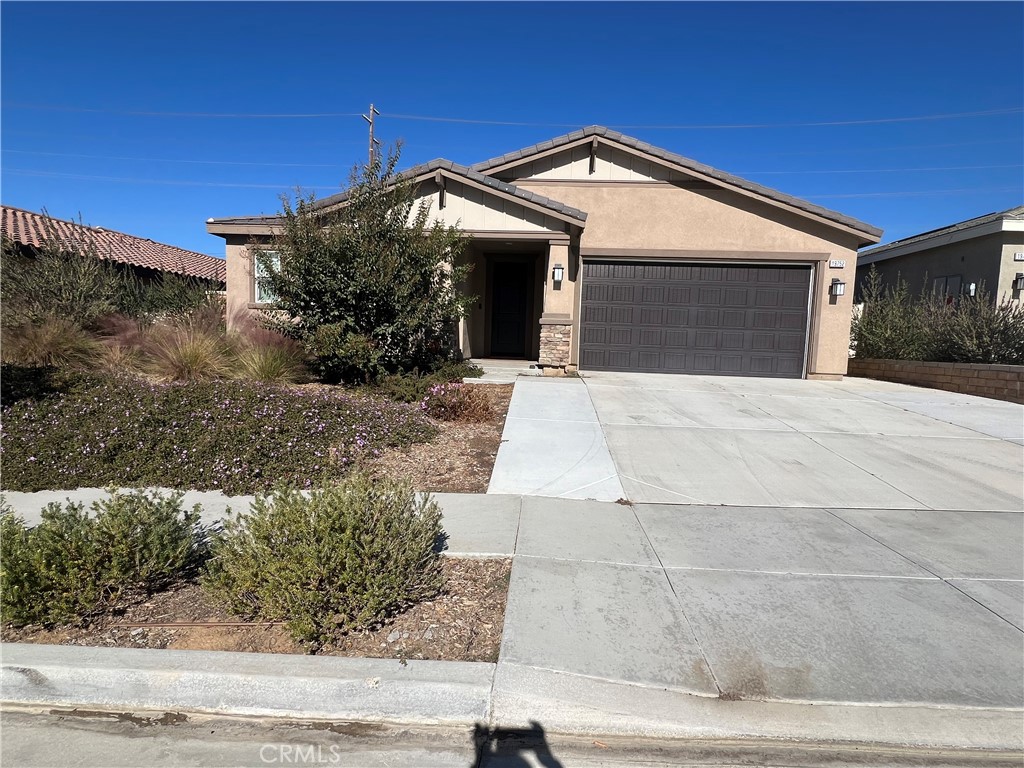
[0,643,495,726]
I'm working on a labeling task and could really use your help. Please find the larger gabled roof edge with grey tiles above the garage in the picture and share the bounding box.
[472,125,882,242]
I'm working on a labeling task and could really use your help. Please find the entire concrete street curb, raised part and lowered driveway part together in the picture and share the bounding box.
[0,643,1024,757]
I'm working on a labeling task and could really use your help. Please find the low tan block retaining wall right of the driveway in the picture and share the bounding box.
[847,357,1024,403]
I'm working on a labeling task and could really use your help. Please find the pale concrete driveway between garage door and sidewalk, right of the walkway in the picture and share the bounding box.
[584,373,1024,512]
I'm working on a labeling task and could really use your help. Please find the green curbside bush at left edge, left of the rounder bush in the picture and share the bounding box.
[0,492,209,626]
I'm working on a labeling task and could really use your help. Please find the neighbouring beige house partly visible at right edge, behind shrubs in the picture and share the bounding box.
[857,206,1024,301]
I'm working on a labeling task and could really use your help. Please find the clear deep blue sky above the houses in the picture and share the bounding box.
[0,2,1024,255]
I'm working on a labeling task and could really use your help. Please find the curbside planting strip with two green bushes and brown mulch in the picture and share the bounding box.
[0,487,510,660]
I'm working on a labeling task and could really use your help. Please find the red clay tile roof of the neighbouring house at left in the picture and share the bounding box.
[0,206,226,283]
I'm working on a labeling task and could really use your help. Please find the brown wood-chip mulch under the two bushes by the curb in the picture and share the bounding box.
[0,557,511,662]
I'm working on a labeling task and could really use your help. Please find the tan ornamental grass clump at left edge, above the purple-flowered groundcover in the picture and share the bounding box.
[2,316,101,369]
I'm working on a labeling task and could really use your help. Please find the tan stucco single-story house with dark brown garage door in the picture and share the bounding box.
[207,126,882,379]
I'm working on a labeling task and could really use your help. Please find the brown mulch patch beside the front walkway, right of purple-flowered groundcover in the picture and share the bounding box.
[364,384,513,494]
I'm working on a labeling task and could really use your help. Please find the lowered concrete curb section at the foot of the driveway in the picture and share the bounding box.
[490,663,1024,756]
